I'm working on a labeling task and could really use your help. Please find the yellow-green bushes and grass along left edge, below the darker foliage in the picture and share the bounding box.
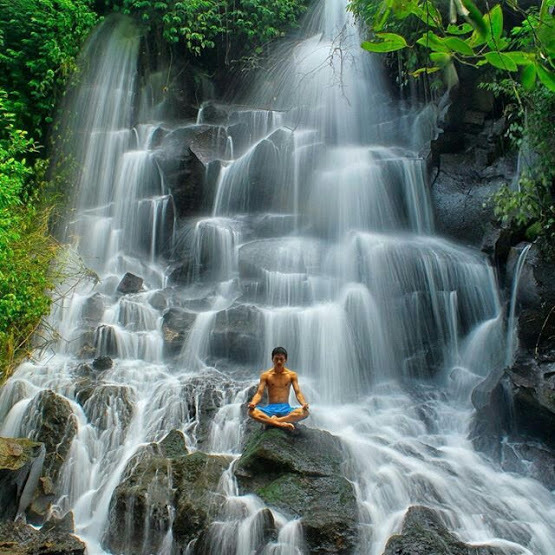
[0,89,55,379]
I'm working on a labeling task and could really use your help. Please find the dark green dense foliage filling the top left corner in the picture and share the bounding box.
[0,0,97,139]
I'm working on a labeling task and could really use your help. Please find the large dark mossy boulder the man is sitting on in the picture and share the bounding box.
[235,427,358,553]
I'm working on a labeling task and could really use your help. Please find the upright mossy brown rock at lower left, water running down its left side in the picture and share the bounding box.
[22,390,77,484]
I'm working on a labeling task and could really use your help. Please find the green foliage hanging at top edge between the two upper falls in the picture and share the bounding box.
[109,0,307,55]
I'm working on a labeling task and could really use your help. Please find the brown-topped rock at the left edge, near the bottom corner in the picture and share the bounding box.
[0,437,46,521]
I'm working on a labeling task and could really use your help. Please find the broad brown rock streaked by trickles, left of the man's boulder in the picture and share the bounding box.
[104,430,230,553]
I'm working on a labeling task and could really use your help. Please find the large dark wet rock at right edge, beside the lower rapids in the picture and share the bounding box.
[470,354,555,489]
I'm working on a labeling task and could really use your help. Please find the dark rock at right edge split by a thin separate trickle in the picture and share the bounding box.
[506,243,555,353]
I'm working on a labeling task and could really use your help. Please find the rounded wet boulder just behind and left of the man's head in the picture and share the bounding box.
[210,305,263,364]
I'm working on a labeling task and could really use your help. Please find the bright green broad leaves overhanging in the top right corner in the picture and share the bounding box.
[350,0,555,92]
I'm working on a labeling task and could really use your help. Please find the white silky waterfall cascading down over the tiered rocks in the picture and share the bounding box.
[0,0,555,555]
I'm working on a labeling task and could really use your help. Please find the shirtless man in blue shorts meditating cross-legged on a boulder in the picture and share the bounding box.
[249,347,308,430]
